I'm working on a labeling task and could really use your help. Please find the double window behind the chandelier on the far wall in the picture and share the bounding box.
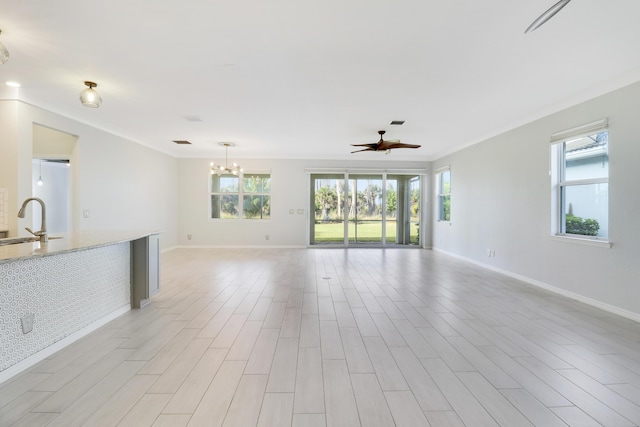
[210,173,271,219]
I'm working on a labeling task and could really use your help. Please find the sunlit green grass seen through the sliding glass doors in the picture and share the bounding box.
[315,220,418,244]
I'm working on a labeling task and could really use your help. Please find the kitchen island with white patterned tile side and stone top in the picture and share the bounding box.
[0,231,159,383]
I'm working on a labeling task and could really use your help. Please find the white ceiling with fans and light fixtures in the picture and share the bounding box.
[0,0,640,160]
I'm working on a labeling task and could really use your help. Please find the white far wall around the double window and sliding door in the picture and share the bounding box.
[178,159,428,247]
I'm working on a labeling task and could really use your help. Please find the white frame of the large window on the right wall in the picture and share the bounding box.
[549,118,611,247]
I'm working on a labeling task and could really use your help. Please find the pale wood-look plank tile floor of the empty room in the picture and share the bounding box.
[0,249,640,427]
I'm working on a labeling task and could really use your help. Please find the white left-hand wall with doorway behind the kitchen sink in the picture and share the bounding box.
[0,100,178,249]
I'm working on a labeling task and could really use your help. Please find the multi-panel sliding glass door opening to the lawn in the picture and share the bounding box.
[309,173,422,246]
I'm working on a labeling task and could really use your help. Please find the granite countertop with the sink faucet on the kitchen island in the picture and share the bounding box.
[0,231,159,263]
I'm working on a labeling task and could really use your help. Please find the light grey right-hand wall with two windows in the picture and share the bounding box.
[433,83,640,318]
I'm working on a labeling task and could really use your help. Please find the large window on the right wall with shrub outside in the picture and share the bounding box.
[551,120,609,240]
